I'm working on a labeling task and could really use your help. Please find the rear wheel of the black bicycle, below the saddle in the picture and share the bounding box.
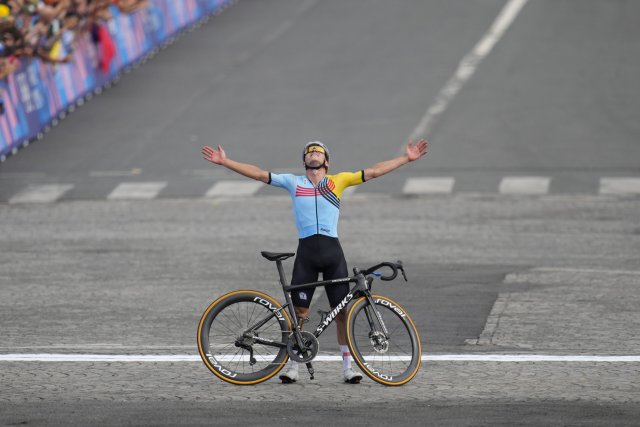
[198,291,291,385]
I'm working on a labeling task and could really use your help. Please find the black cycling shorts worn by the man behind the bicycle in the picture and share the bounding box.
[291,234,349,308]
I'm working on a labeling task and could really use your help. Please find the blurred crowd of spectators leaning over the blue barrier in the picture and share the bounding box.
[0,0,148,79]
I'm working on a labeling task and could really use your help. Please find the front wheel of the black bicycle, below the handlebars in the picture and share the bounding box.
[347,295,422,386]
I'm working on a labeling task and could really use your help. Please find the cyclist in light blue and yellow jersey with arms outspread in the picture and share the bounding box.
[202,139,429,384]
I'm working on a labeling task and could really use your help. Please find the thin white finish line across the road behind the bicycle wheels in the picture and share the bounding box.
[0,353,640,363]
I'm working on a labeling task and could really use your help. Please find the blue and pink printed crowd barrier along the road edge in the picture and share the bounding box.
[0,0,231,161]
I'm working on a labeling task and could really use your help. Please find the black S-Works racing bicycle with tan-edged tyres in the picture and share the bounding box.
[197,252,422,386]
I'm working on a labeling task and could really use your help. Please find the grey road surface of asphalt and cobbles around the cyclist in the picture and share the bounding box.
[0,0,640,425]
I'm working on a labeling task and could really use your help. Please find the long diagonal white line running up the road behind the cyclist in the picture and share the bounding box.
[410,0,527,142]
